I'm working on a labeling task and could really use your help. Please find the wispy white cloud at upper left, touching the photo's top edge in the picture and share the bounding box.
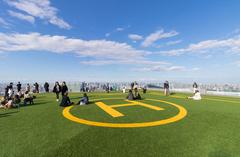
[5,0,71,29]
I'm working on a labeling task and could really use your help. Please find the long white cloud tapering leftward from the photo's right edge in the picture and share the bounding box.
[160,38,240,56]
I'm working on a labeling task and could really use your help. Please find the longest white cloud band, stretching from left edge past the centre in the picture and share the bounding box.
[0,33,150,60]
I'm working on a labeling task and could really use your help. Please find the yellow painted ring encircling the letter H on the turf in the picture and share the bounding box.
[62,98,187,128]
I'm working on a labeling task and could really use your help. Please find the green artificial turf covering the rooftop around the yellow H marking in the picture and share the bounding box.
[0,91,240,157]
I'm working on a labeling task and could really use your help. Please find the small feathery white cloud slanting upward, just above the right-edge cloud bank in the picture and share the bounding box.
[142,29,179,47]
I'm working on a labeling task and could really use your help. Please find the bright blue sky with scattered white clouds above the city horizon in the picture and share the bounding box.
[0,0,240,83]
